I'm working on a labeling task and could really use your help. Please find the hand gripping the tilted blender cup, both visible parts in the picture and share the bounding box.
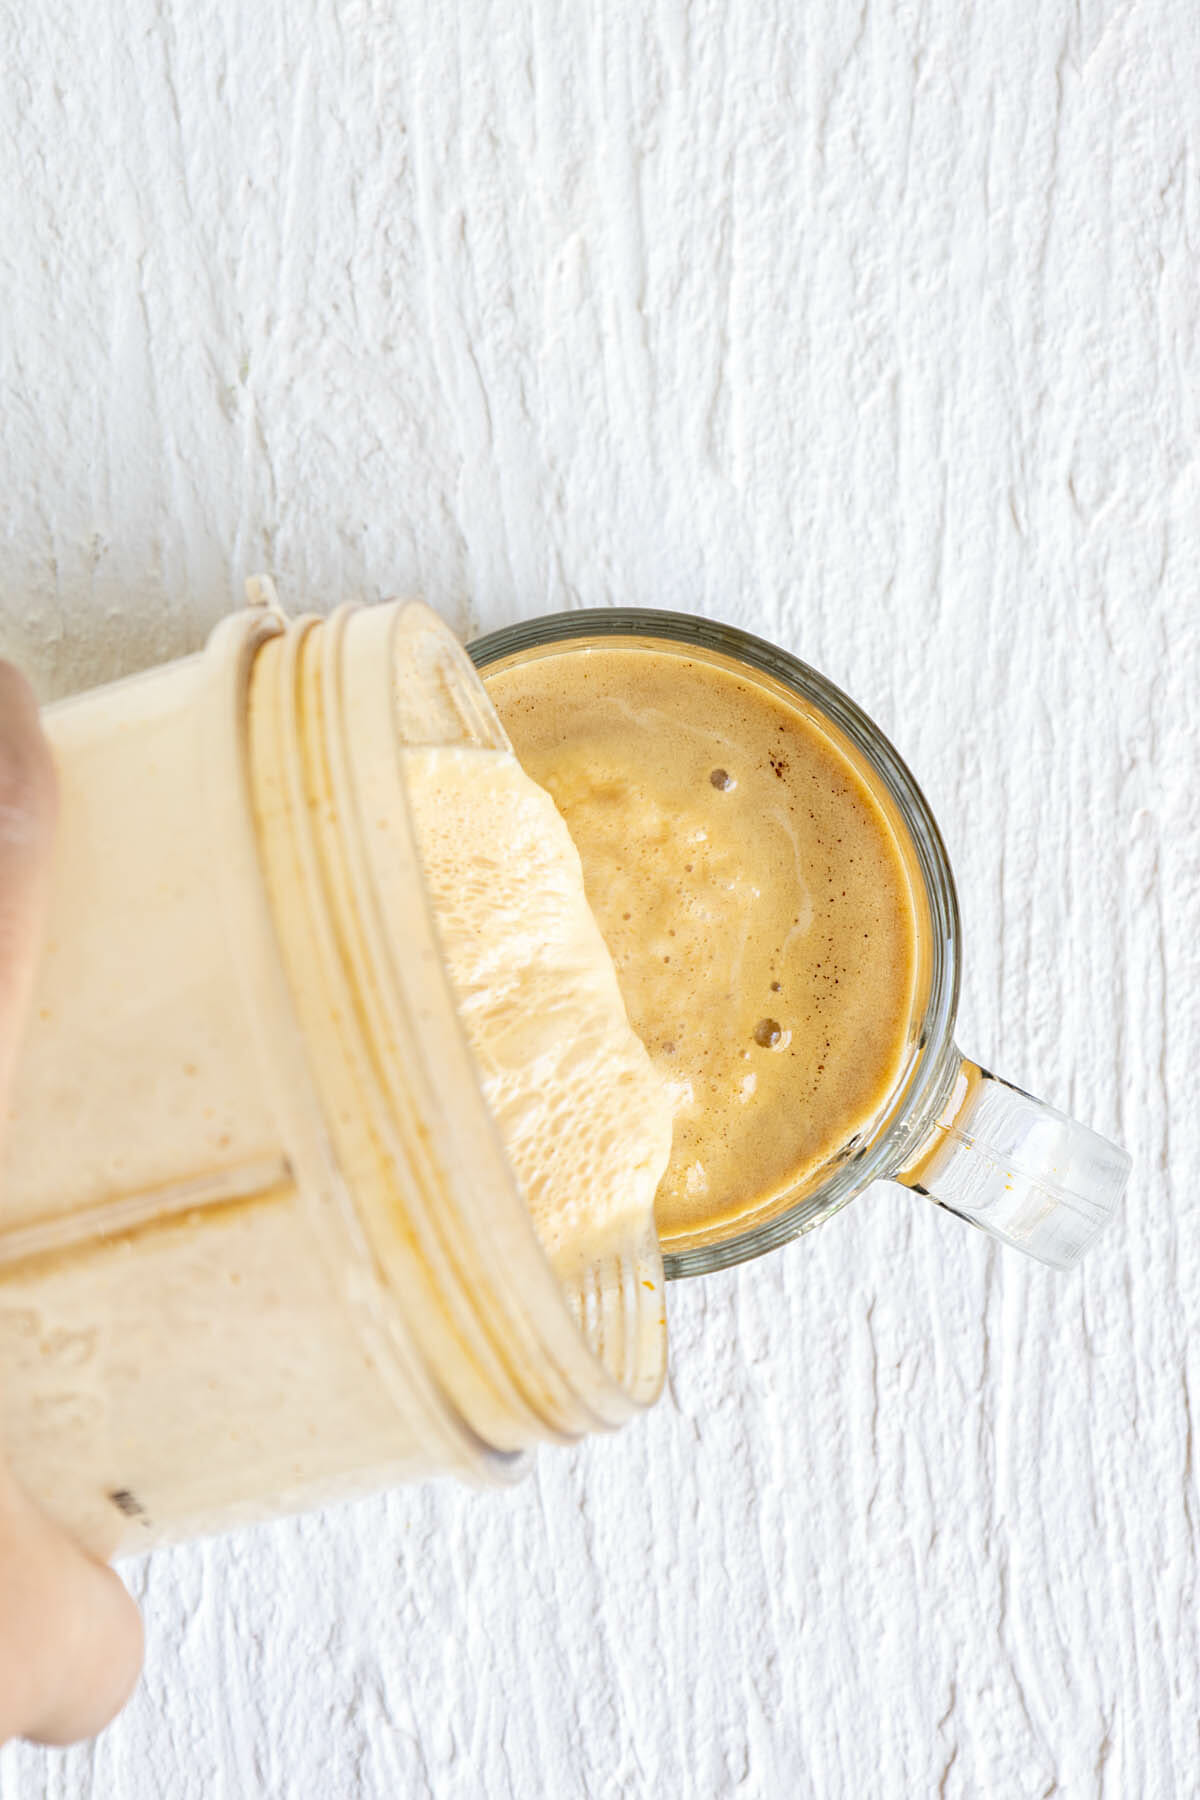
[0,662,142,1744]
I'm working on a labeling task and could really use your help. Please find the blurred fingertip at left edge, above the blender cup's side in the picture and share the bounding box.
[0,662,56,1080]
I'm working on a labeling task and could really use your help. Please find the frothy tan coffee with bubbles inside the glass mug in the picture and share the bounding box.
[484,644,916,1246]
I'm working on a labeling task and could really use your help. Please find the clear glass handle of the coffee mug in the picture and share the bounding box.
[892,1049,1132,1269]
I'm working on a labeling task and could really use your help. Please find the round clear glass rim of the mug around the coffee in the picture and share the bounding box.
[466,607,963,1280]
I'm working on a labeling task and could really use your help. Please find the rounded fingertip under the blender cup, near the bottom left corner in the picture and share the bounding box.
[0,1467,142,1744]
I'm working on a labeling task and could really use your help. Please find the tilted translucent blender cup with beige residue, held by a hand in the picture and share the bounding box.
[0,603,666,1555]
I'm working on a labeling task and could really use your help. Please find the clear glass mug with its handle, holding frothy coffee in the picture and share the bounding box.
[468,608,1130,1278]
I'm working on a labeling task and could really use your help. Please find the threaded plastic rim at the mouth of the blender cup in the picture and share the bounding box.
[241,603,666,1456]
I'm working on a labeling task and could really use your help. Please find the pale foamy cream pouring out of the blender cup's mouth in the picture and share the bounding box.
[405,749,671,1283]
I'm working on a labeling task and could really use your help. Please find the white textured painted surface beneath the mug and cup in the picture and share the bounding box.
[0,0,1200,1800]
